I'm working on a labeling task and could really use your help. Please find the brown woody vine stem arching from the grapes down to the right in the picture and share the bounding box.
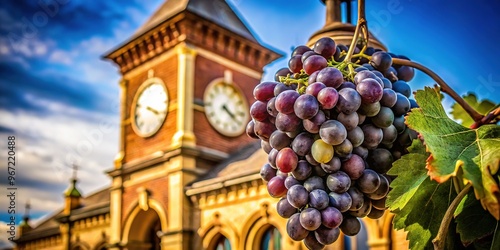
[392,58,484,122]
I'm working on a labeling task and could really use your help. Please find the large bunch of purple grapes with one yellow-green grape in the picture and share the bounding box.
[246,38,417,249]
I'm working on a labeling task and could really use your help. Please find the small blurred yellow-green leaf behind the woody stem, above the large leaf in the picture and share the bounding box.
[450,93,495,127]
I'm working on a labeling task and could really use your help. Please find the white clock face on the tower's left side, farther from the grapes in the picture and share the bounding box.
[132,80,168,137]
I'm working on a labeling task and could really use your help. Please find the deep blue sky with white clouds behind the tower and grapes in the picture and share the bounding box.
[0,0,500,246]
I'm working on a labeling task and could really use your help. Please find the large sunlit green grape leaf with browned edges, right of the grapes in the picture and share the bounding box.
[406,87,500,220]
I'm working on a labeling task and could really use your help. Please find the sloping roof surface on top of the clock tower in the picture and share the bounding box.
[132,0,257,42]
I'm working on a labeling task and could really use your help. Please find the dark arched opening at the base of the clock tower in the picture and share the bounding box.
[127,209,161,250]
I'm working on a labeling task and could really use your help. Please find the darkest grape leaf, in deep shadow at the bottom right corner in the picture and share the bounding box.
[455,191,497,246]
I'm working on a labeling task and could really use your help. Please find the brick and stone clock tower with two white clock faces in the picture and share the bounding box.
[104,0,280,249]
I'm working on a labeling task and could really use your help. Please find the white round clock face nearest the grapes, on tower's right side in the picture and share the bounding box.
[203,82,249,136]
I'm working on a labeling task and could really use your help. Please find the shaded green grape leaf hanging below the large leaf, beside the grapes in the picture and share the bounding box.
[386,139,455,249]
